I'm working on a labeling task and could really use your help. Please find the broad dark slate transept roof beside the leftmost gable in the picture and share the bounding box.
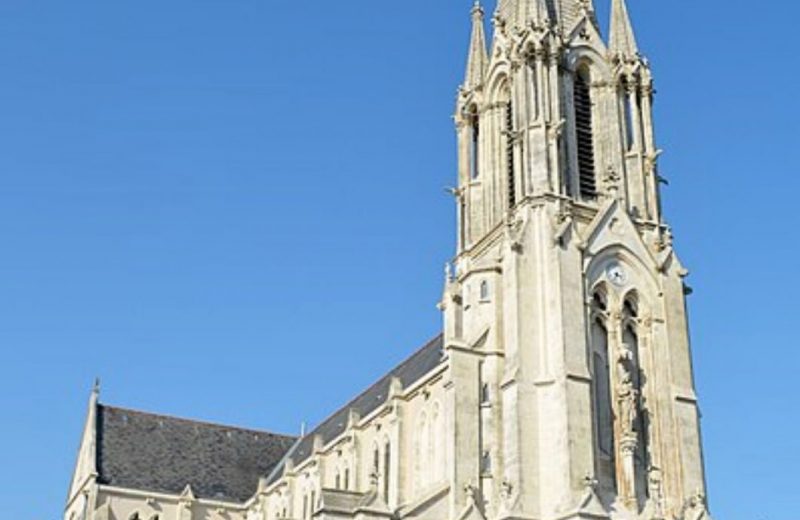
[97,405,297,502]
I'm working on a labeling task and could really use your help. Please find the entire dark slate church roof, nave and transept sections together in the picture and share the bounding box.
[92,335,444,503]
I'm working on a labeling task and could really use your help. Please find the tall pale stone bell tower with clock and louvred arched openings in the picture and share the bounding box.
[441,0,709,520]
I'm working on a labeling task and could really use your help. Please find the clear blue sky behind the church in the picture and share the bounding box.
[0,0,800,520]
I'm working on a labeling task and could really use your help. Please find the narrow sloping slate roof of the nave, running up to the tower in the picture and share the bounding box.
[272,334,444,482]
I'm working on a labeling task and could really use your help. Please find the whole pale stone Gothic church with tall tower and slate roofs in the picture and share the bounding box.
[64,0,710,520]
